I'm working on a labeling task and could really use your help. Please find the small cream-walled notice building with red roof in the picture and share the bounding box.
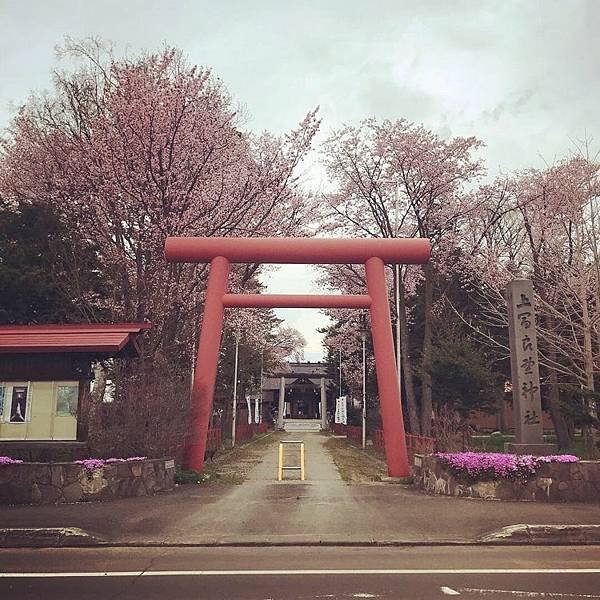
[0,323,150,457]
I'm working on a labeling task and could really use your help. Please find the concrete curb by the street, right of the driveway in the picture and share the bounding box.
[479,523,600,546]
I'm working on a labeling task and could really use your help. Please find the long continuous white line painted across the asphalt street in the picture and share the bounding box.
[0,568,600,579]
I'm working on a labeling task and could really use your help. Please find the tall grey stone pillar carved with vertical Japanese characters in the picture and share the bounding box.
[504,279,557,455]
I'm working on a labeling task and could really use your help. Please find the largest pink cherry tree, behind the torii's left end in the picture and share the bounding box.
[0,43,318,366]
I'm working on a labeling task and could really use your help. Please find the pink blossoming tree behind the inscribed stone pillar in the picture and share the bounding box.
[454,156,600,448]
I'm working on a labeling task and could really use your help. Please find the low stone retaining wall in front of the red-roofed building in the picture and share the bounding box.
[0,459,175,504]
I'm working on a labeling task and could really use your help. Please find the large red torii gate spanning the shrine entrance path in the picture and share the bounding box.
[165,237,431,477]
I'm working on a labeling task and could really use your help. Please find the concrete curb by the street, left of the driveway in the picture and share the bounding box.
[0,527,103,548]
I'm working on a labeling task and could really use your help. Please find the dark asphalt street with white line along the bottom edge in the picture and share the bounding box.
[0,547,600,600]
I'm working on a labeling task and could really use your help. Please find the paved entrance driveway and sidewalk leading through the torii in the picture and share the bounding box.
[0,433,600,544]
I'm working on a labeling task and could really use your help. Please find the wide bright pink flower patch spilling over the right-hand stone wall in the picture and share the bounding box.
[434,452,579,481]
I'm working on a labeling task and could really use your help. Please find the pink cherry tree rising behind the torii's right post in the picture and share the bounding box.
[324,119,483,435]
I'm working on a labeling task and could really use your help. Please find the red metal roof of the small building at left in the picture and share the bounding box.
[0,323,151,357]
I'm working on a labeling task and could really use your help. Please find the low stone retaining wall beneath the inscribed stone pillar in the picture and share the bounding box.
[413,455,600,503]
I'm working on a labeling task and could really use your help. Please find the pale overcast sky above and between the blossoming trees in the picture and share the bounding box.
[0,0,600,360]
